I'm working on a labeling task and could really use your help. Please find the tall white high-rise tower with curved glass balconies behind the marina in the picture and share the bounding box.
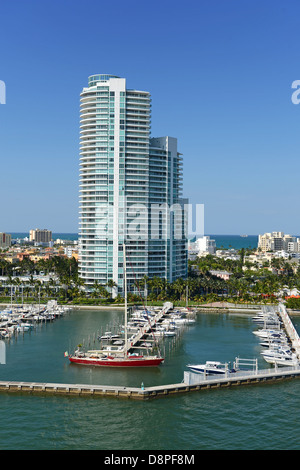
[79,75,187,293]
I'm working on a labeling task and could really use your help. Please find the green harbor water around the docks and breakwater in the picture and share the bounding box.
[0,310,300,451]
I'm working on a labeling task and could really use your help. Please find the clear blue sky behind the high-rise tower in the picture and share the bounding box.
[0,0,300,234]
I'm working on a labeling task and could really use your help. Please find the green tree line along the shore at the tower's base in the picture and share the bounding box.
[0,249,300,304]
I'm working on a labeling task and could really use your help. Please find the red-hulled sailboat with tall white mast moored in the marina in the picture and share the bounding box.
[66,244,164,367]
